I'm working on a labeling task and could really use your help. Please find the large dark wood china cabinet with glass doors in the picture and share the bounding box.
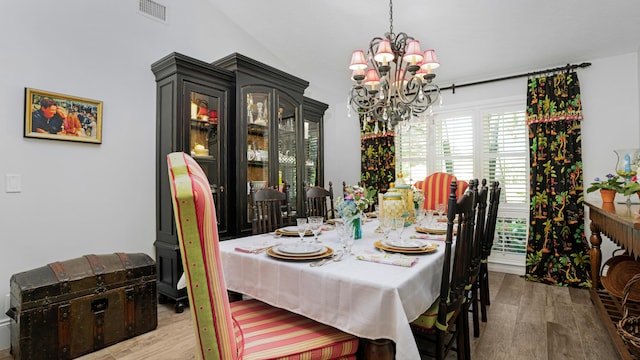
[151,53,327,312]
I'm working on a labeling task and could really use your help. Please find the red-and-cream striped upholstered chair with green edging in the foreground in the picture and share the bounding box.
[167,153,358,360]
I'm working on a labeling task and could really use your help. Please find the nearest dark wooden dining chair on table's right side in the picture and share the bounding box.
[411,180,475,360]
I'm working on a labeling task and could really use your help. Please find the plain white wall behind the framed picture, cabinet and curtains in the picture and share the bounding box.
[0,0,640,349]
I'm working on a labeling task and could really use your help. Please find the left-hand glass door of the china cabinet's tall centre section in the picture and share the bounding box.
[245,90,274,194]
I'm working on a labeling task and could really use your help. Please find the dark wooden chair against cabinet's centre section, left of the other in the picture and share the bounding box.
[250,184,291,235]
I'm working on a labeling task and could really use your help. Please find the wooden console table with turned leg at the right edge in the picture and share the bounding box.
[584,201,640,360]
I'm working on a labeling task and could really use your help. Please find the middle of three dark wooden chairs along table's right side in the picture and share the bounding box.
[467,179,489,337]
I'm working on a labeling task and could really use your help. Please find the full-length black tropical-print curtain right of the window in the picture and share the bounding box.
[526,72,591,287]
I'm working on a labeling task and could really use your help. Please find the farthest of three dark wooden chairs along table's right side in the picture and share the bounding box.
[478,181,502,322]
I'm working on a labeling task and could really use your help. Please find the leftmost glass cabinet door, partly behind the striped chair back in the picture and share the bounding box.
[185,84,227,231]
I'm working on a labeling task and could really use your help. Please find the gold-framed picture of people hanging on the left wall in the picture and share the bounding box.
[24,88,102,144]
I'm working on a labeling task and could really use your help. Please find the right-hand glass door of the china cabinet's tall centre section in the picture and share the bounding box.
[278,96,299,215]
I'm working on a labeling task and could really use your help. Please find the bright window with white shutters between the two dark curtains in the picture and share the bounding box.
[396,103,529,266]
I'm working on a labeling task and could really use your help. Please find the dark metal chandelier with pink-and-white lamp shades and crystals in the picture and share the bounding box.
[348,0,440,129]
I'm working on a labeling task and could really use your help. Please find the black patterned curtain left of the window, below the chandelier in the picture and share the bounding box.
[360,119,396,203]
